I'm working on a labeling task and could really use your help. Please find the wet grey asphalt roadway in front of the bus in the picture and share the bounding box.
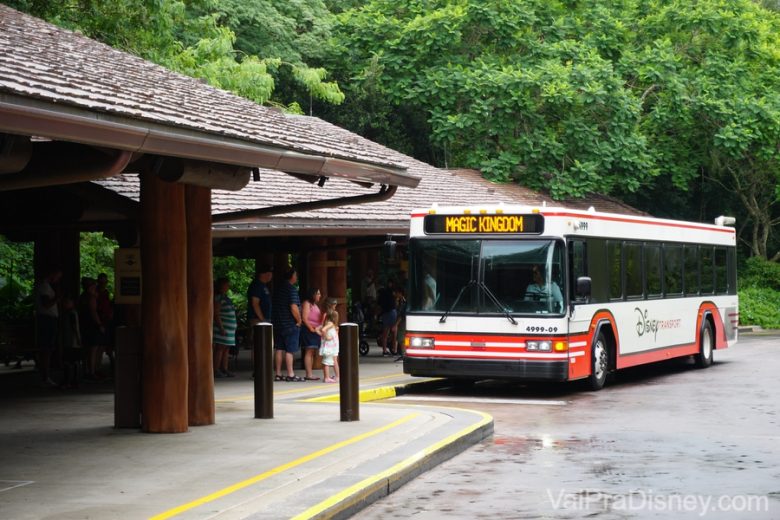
[356,336,780,519]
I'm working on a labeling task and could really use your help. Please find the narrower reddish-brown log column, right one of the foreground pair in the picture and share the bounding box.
[185,185,215,426]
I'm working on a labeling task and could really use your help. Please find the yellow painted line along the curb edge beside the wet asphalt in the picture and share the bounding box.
[292,410,493,520]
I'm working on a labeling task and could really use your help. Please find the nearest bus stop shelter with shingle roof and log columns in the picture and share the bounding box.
[0,5,419,432]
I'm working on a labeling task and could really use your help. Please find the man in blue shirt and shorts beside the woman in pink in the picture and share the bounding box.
[272,267,303,381]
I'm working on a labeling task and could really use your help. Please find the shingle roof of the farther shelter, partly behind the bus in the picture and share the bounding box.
[96,138,643,235]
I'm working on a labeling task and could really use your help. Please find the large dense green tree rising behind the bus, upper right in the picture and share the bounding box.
[326,0,780,256]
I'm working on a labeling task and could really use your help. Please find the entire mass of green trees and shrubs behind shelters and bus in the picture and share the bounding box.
[0,0,780,325]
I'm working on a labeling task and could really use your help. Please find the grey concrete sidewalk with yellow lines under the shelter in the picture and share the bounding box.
[0,356,493,519]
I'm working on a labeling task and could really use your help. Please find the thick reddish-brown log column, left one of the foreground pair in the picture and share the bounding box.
[141,173,188,433]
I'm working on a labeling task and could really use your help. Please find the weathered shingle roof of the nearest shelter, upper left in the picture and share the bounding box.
[0,5,414,169]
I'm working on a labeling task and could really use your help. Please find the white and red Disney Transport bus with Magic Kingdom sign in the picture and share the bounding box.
[404,204,739,390]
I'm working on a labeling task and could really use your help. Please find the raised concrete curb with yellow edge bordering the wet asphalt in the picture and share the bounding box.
[293,408,493,520]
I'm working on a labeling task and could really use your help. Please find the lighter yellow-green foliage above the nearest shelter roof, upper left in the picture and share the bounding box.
[2,0,344,105]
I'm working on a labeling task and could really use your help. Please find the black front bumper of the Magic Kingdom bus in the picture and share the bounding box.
[404,357,569,381]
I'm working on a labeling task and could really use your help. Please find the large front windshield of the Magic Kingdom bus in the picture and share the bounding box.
[408,239,565,315]
